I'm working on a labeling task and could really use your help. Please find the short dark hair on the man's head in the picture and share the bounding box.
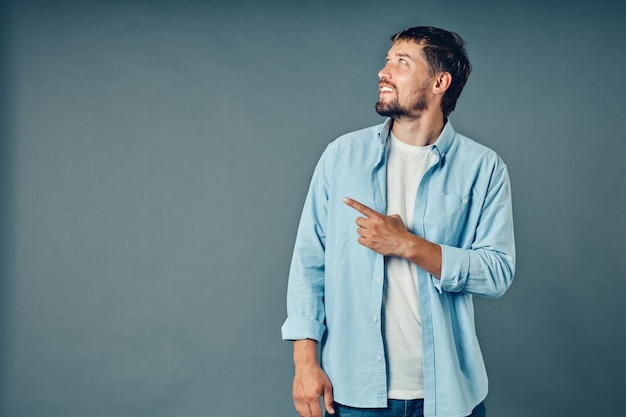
[391,26,472,117]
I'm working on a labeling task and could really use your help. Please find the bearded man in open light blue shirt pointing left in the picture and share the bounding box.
[282,27,515,417]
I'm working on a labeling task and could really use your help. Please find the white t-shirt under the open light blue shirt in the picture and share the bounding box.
[383,135,436,400]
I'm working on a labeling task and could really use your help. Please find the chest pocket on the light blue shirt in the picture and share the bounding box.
[424,194,473,247]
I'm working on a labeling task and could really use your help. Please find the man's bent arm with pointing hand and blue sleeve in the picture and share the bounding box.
[344,184,515,297]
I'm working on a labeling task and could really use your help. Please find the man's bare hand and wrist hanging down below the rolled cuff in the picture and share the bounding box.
[292,339,335,417]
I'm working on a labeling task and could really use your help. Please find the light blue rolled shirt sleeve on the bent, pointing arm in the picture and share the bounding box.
[433,160,515,298]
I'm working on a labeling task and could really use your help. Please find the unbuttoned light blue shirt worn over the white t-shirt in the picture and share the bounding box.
[282,119,515,417]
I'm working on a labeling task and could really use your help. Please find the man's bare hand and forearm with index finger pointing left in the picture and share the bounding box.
[343,197,442,278]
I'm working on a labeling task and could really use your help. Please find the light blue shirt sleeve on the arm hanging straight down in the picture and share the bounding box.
[282,148,330,342]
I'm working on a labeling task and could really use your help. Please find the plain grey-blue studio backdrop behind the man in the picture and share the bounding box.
[0,0,626,417]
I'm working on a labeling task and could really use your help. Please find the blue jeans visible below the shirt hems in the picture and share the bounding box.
[326,400,487,417]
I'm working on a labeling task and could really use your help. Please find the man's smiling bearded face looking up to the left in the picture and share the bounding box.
[376,41,433,120]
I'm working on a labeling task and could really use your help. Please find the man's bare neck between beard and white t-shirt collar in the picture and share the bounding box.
[391,112,445,146]
